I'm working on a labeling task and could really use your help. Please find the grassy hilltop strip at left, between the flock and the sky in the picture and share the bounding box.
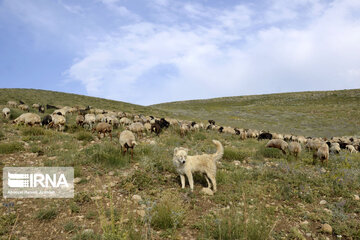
[0,88,166,116]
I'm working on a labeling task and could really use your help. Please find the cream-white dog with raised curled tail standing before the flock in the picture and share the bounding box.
[173,140,224,192]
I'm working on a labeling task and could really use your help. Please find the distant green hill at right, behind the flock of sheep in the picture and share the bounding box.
[152,89,360,137]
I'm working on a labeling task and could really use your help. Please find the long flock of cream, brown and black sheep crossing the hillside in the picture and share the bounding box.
[2,101,360,163]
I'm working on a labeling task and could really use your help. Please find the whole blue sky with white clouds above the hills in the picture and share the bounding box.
[0,0,360,105]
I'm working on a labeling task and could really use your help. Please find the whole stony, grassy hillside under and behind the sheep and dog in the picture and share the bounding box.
[0,89,360,240]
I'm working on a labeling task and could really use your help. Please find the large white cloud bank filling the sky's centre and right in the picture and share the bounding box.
[67,0,360,104]
